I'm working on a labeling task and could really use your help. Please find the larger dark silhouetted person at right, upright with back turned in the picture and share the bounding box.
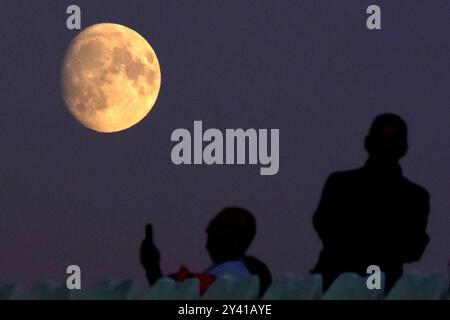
[312,114,429,291]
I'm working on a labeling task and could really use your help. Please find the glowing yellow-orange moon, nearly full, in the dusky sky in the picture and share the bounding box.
[61,23,161,133]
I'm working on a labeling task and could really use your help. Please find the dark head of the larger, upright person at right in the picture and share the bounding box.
[365,113,408,164]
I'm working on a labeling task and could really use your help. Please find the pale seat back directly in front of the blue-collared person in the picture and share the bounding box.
[202,275,259,300]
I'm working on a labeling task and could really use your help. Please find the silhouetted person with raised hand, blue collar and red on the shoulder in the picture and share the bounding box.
[140,207,272,295]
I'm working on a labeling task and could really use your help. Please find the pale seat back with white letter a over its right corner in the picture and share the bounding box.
[322,273,384,300]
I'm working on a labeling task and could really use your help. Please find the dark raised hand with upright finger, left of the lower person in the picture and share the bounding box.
[140,224,162,285]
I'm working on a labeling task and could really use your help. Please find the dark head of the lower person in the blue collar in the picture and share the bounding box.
[206,207,256,263]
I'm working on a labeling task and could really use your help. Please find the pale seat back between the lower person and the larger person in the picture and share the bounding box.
[263,274,322,300]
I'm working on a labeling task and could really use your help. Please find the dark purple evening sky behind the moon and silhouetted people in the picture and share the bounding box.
[0,0,450,282]
